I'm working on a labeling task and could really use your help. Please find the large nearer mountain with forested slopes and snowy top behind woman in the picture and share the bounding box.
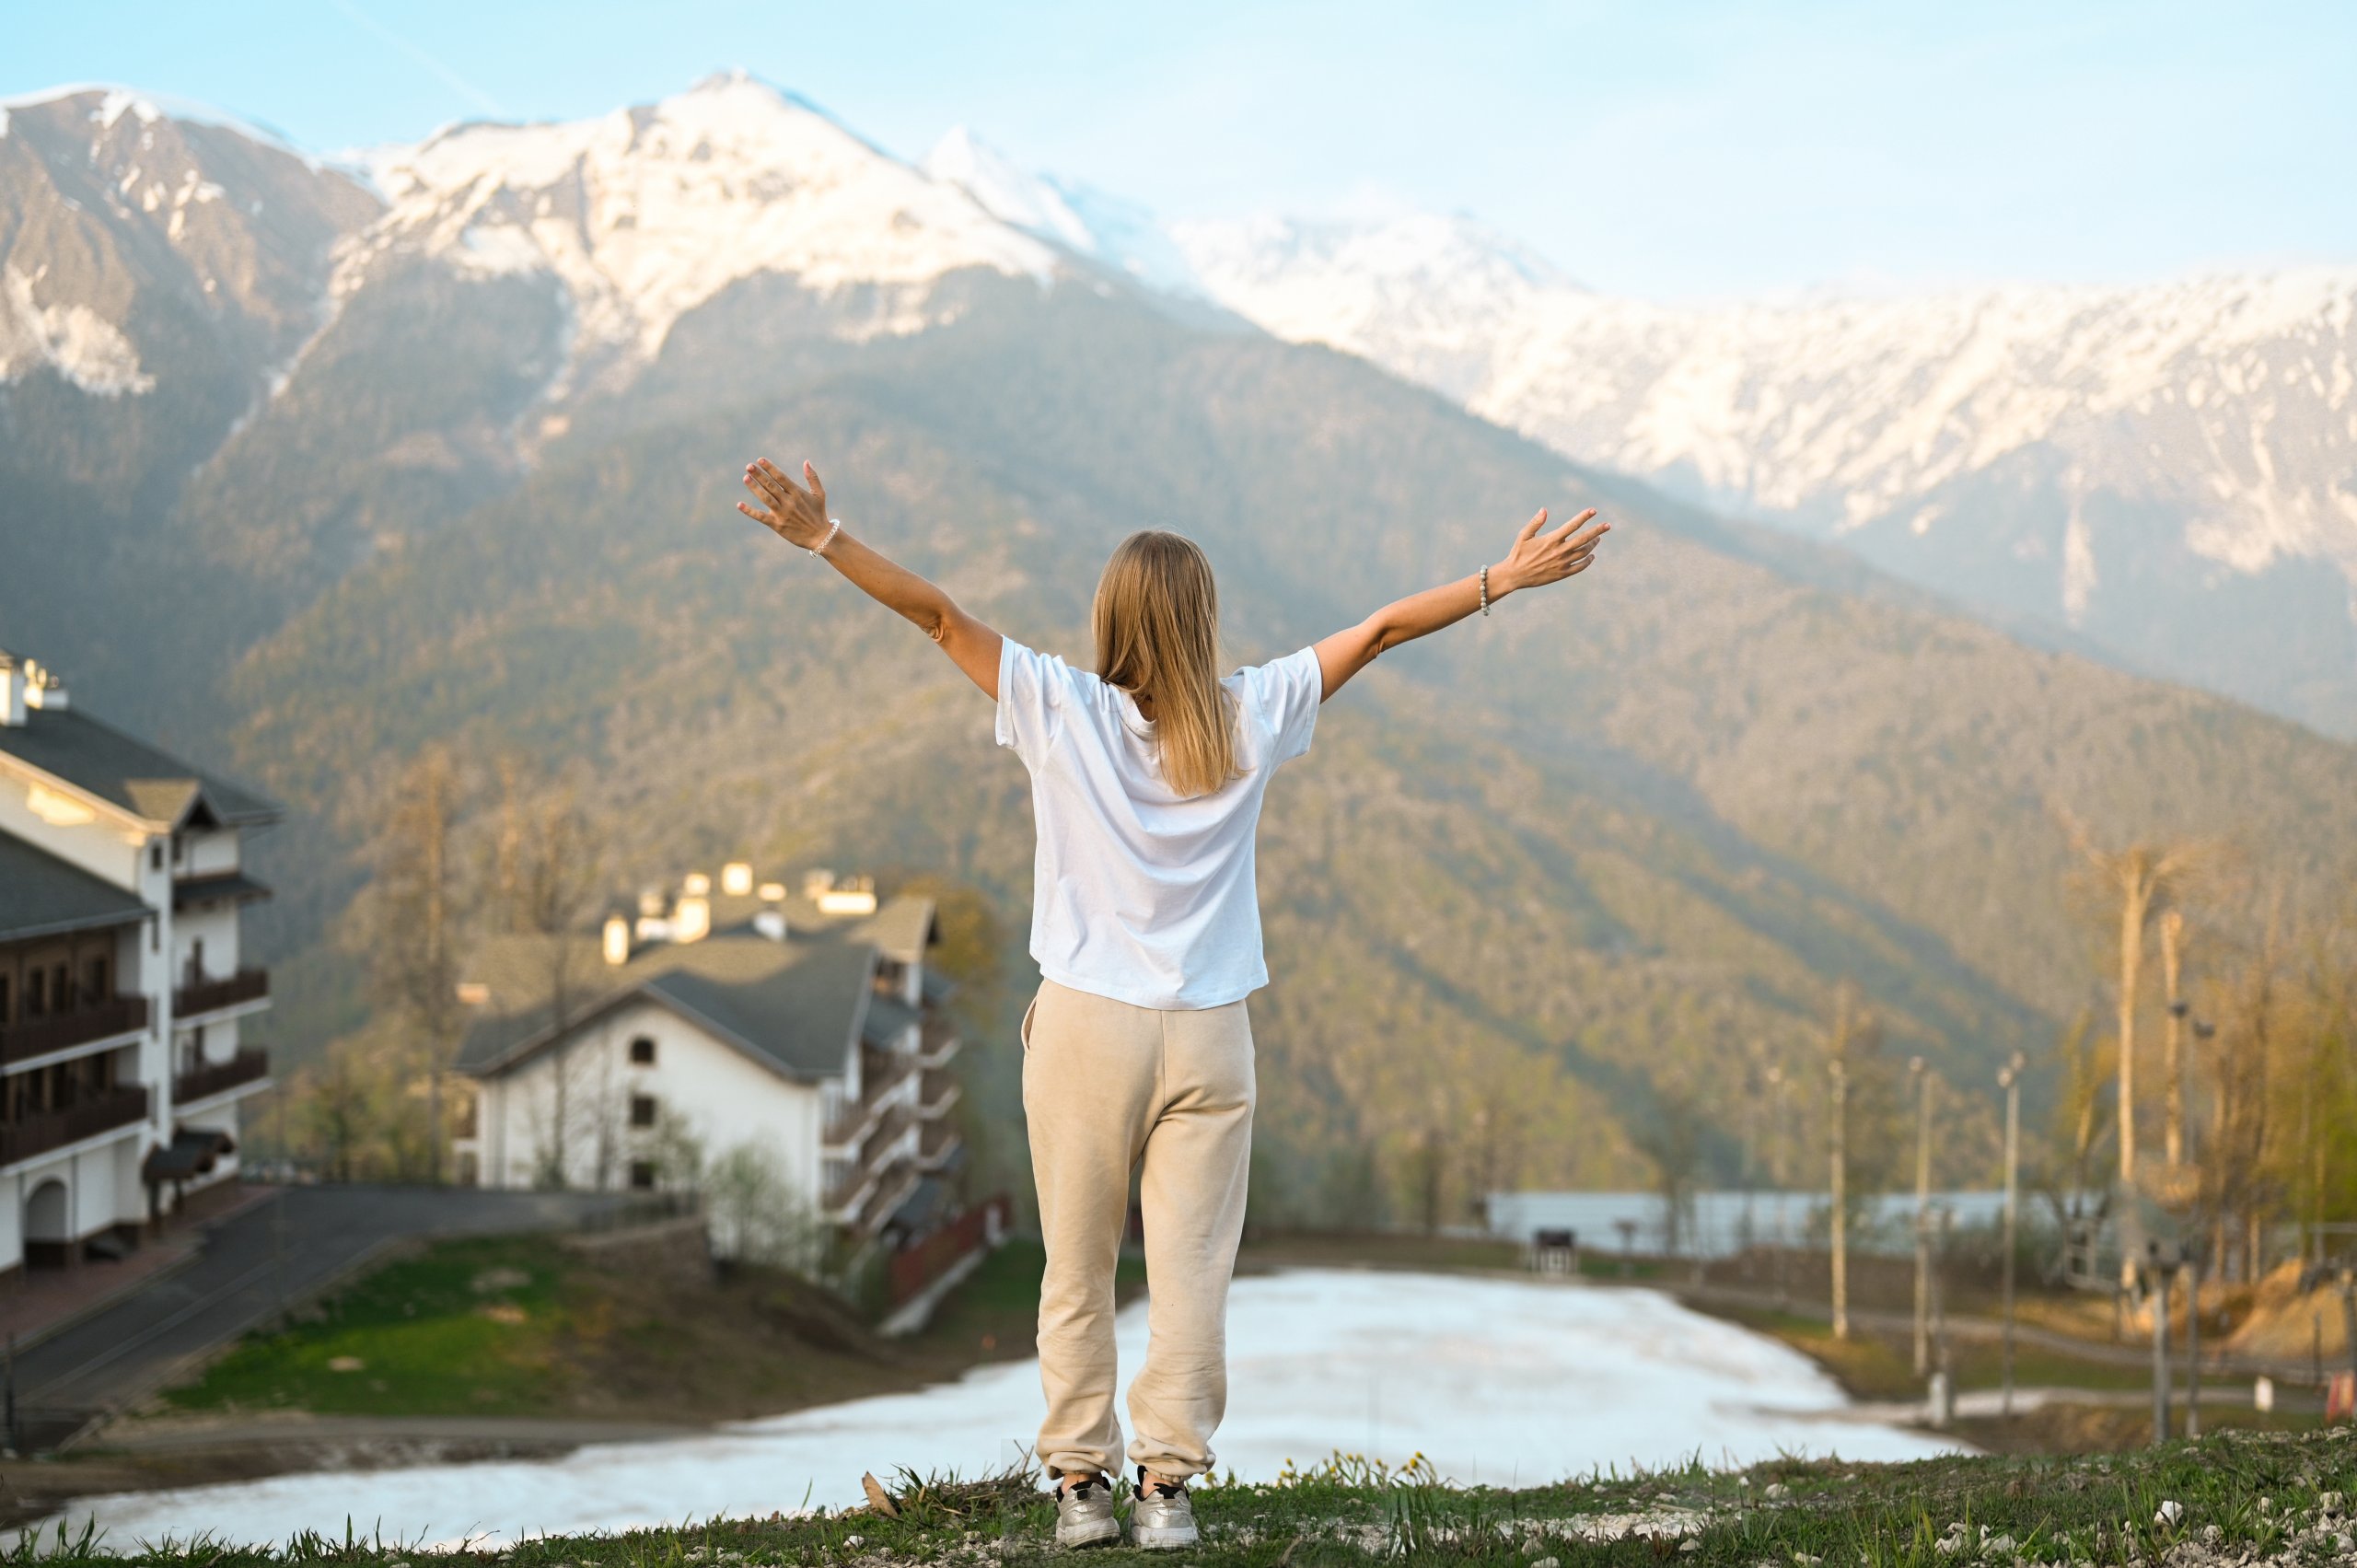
[0,78,2357,1197]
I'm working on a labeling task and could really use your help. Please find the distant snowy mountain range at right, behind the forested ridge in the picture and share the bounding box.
[926,130,2357,738]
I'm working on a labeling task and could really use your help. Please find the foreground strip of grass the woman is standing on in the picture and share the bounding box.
[17,1429,2357,1568]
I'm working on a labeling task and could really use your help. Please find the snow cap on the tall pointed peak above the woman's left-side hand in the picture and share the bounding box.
[346,71,1056,377]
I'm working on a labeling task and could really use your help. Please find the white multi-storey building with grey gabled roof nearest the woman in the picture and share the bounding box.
[455,863,959,1243]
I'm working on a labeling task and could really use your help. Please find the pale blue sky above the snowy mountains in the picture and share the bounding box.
[0,0,2357,299]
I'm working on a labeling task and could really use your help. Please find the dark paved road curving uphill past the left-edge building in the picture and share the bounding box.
[17,1186,645,1447]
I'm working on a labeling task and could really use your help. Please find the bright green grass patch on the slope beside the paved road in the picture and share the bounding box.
[165,1237,571,1415]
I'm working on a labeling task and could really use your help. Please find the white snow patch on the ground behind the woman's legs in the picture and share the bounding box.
[59,1271,1954,1547]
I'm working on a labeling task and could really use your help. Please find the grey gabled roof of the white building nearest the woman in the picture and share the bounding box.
[458,936,875,1077]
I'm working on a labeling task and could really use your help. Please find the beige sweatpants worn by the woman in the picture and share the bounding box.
[1023,981,1254,1481]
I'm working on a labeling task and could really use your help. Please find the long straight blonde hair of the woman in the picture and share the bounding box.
[1089,528,1242,795]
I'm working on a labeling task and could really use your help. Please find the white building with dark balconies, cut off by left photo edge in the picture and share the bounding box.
[0,653,278,1271]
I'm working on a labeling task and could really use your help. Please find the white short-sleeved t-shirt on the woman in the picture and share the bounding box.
[999,639,1325,1009]
